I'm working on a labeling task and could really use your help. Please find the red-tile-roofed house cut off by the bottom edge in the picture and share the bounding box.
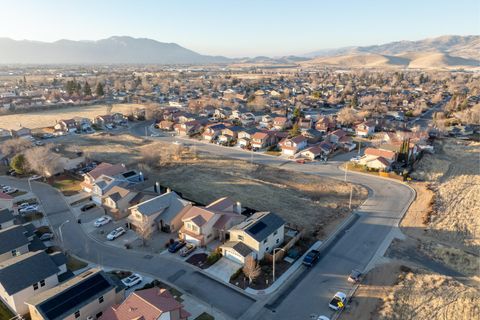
[101,287,190,320]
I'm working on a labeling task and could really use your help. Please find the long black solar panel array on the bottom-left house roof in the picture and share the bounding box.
[38,273,110,320]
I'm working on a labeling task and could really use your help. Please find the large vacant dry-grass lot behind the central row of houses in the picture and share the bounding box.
[54,133,367,238]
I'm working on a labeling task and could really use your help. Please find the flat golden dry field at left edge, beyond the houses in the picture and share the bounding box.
[0,104,141,130]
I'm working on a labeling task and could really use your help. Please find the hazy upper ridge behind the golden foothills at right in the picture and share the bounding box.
[305,35,480,60]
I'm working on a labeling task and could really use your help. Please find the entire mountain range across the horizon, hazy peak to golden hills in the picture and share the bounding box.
[0,35,480,69]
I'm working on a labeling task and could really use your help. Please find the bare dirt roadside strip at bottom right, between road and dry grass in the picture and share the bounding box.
[341,262,401,320]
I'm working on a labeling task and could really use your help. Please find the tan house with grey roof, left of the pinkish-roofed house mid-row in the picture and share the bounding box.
[128,191,192,233]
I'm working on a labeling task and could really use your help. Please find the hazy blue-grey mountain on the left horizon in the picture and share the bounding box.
[0,37,230,64]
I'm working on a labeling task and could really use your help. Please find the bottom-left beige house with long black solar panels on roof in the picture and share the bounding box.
[26,269,125,320]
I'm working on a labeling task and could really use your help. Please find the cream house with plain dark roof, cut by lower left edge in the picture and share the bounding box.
[0,251,67,315]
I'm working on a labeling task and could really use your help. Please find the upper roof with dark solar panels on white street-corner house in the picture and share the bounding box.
[233,212,285,242]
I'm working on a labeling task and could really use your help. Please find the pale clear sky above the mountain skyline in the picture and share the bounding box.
[0,0,480,57]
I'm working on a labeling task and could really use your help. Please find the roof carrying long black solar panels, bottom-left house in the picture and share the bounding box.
[27,269,116,320]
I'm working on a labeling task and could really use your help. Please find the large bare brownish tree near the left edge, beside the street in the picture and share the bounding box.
[25,144,62,177]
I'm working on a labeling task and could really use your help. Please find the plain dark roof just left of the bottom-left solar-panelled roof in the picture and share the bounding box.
[0,251,60,295]
